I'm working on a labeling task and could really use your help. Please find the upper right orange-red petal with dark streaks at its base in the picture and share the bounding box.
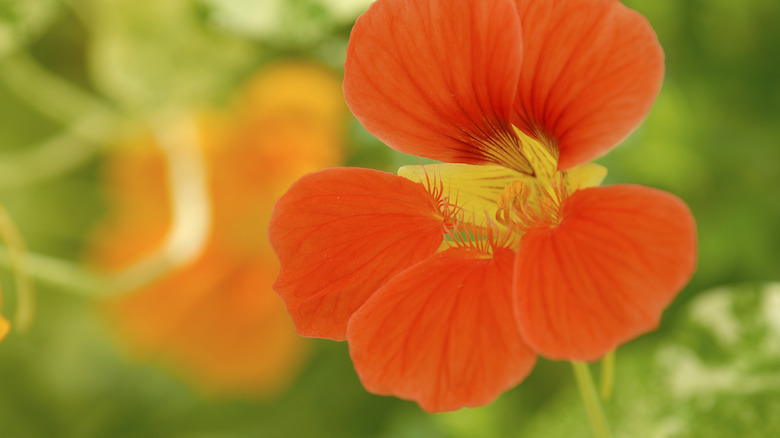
[513,0,664,170]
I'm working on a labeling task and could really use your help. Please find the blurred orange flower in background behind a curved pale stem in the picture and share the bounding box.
[90,62,347,395]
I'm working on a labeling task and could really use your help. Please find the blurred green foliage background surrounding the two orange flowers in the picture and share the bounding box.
[0,0,780,438]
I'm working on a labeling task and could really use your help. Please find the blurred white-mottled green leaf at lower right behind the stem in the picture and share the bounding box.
[527,283,780,438]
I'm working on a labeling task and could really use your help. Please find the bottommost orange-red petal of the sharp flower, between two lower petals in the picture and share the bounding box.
[348,248,536,412]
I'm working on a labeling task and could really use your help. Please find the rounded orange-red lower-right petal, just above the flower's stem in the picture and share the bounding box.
[514,185,696,360]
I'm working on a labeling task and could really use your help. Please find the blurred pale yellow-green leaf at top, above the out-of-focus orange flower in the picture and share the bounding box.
[87,0,254,113]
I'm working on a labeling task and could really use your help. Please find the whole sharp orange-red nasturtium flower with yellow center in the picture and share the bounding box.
[269,0,696,411]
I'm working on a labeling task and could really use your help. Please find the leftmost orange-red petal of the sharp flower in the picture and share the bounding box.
[268,168,444,340]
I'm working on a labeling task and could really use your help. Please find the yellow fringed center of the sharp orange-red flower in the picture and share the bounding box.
[398,125,606,250]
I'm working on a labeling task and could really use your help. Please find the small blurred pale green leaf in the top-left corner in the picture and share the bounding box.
[0,0,61,57]
